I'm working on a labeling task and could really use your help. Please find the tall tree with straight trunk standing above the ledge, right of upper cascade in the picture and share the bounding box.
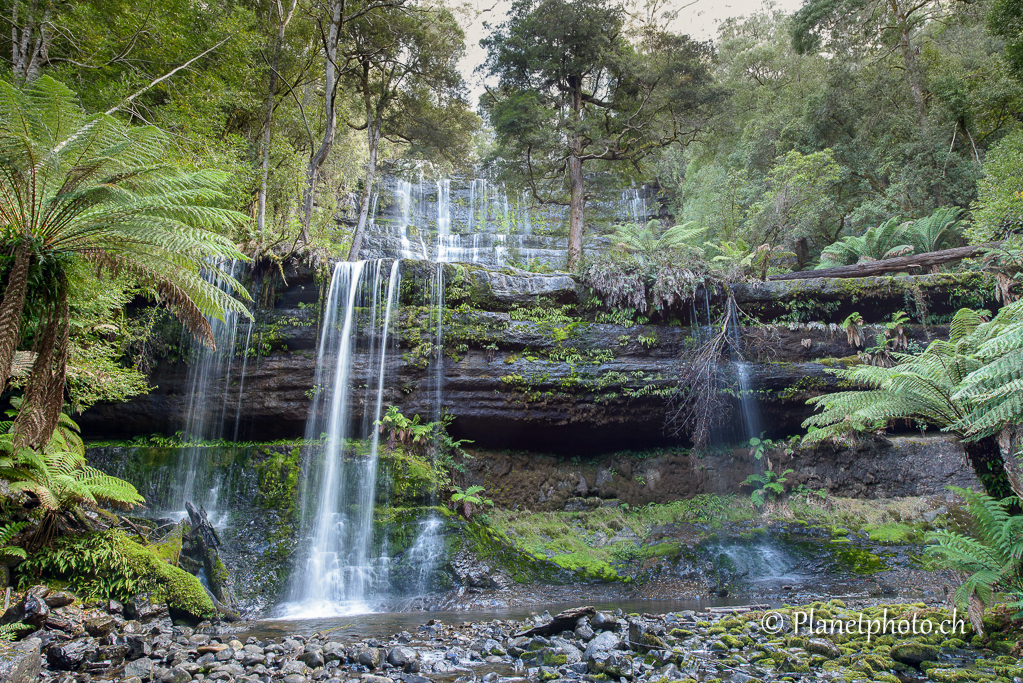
[481,0,717,268]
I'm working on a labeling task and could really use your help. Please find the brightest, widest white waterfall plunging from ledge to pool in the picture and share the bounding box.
[280,260,400,619]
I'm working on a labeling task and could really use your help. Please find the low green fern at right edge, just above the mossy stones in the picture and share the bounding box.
[927,487,1023,617]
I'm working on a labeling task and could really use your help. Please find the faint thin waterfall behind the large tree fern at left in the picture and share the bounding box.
[166,261,252,523]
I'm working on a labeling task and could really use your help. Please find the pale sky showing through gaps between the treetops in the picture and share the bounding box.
[462,0,803,106]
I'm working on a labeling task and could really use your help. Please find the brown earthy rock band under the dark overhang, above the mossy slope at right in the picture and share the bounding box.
[465,435,980,510]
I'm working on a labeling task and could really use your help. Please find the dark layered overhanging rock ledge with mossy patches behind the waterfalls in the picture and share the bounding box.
[79,261,979,454]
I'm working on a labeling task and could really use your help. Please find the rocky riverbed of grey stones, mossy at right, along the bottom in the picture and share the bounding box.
[0,586,1023,683]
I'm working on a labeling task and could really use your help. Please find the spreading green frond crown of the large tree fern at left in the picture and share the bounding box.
[0,77,249,342]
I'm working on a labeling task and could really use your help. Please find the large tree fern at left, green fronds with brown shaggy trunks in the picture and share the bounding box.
[0,76,249,450]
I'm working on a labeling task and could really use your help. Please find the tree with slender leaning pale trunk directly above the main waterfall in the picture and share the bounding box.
[344,7,478,261]
